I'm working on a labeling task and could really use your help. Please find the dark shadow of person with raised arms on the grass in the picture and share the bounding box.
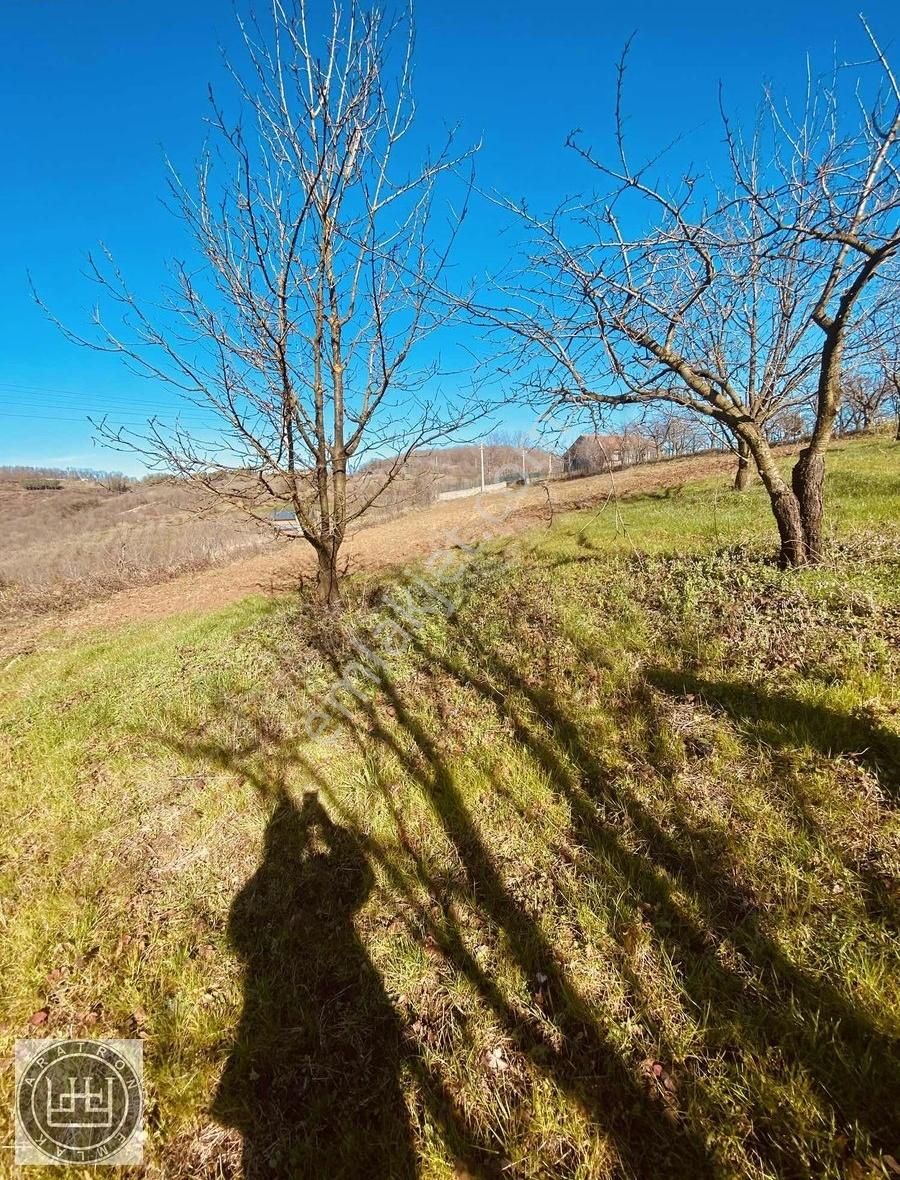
[212,793,416,1180]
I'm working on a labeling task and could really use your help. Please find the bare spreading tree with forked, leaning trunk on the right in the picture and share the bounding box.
[473,21,900,565]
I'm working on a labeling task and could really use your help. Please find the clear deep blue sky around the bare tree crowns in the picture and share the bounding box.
[0,0,900,471]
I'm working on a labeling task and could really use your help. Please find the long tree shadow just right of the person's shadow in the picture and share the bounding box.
[293,632,717,1176]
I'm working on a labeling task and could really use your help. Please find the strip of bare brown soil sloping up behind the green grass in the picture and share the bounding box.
[0,440,844,657]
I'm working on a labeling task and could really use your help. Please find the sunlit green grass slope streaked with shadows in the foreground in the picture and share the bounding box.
[0,439,900,1180]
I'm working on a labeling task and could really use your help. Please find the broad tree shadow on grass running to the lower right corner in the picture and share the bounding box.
[405,608,900,1175]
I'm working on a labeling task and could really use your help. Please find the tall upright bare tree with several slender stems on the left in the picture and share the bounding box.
[43,0,482,604]
